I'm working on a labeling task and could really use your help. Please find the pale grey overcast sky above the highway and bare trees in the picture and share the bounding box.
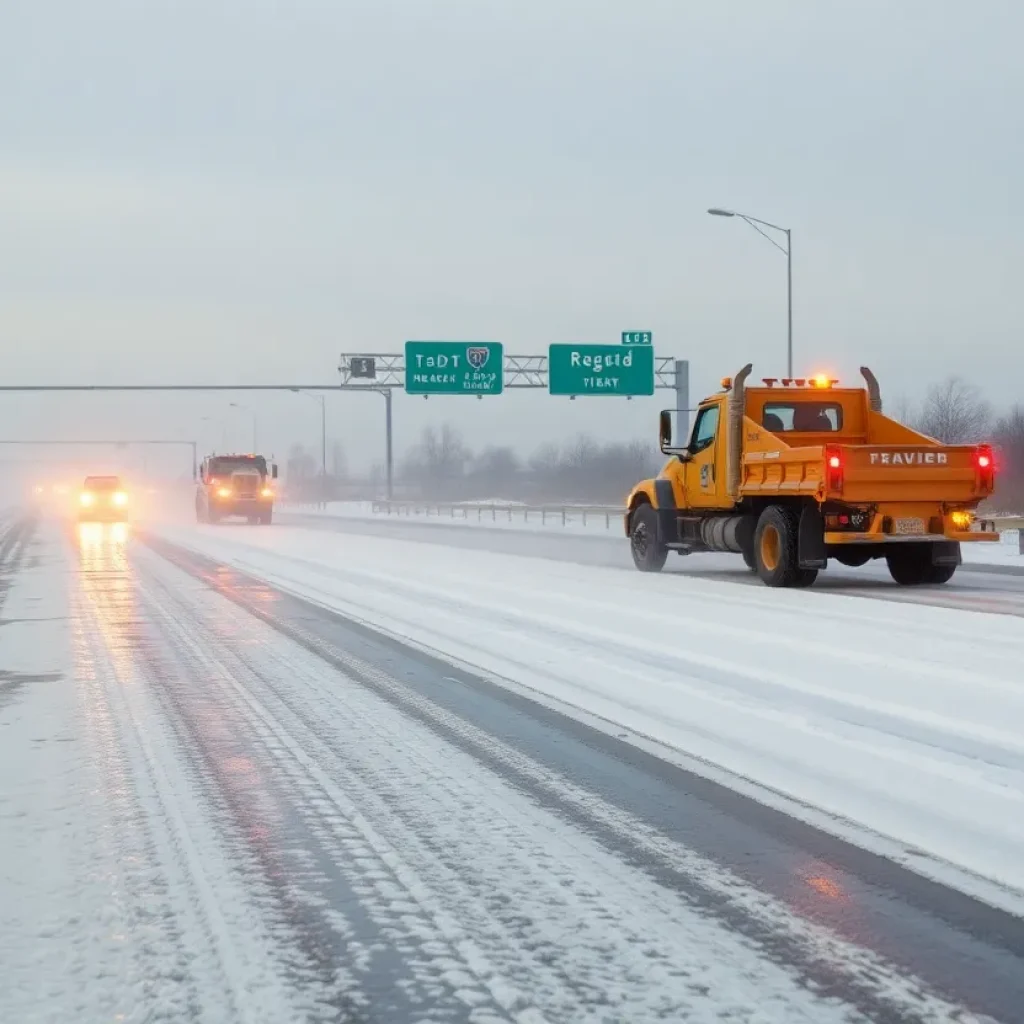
[0,0,1024,465]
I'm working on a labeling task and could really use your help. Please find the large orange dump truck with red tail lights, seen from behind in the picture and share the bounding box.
[626,364,998,587]
